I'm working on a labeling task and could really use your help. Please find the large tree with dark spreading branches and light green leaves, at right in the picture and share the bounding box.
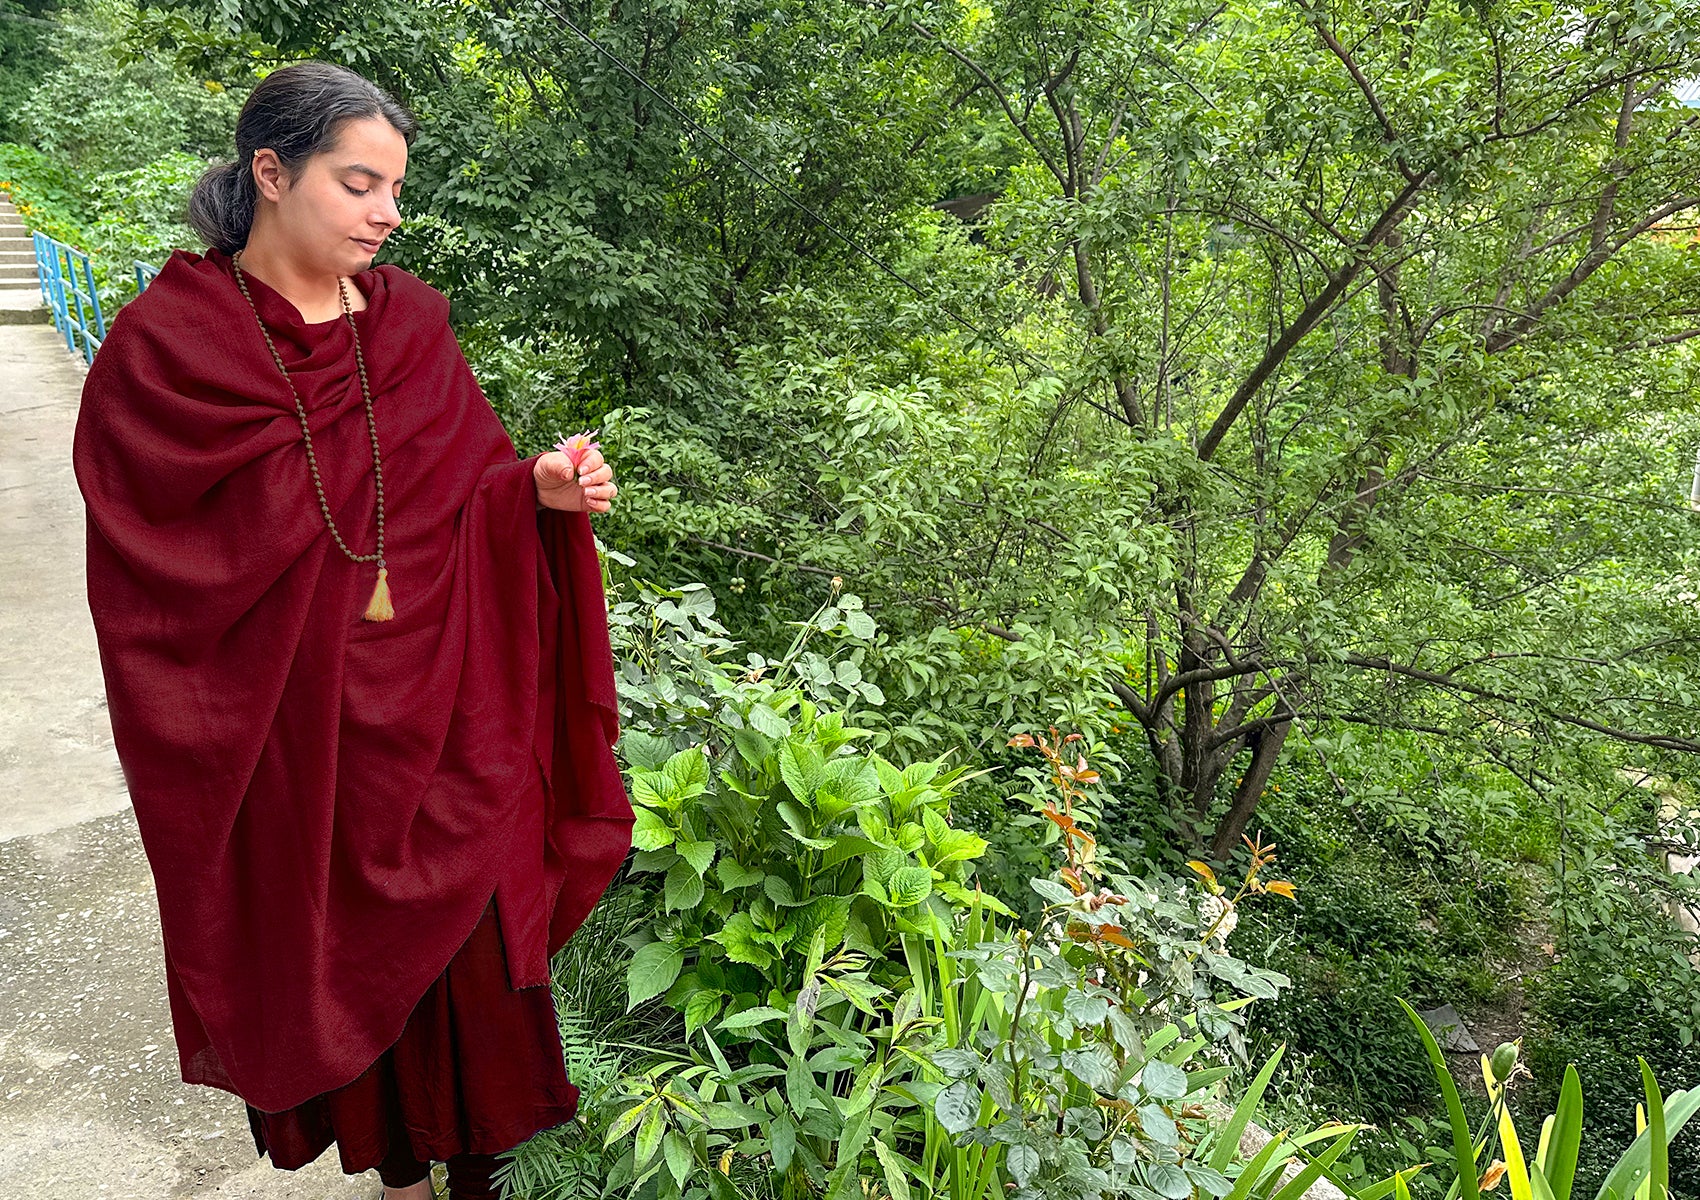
[915,2,1700,858]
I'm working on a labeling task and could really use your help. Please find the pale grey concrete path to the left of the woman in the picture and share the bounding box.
[0,323,382,1200]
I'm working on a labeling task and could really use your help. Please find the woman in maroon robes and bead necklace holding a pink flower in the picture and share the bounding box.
[73,63,632,1200]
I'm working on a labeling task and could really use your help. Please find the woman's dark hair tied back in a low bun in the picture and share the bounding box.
[189,59,418,255]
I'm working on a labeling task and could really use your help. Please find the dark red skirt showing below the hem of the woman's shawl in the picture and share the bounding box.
[248,896,578,1175]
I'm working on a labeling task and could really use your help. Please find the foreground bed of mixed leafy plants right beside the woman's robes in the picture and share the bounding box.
[574,571,1312,1200]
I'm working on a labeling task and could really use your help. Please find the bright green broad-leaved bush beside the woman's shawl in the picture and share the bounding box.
[622,710,986,1033]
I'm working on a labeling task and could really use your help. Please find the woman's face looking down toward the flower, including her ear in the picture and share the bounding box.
[250,117,408,275]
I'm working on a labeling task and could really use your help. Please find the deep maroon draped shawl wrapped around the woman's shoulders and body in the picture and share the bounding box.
[71,250,632,1112]
